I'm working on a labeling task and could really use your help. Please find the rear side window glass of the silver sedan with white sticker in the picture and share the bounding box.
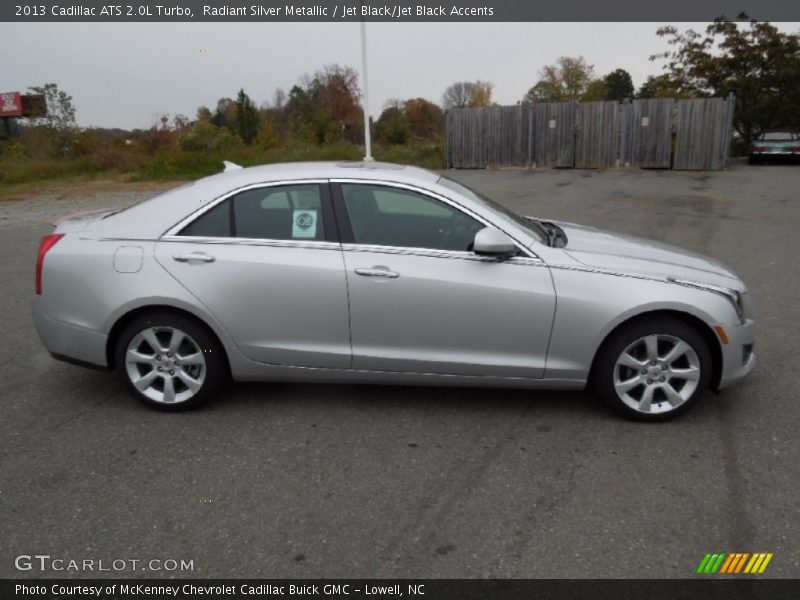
[179,184,325,240]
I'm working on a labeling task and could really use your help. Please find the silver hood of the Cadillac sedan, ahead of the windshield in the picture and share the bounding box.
[558,223,744,291]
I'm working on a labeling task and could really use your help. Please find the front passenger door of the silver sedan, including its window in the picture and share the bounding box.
[335,182,555,378]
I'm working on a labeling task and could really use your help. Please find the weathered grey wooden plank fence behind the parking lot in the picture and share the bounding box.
[445,97,733,170]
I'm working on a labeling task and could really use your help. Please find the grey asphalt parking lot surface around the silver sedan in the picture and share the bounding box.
[0,164,800,578]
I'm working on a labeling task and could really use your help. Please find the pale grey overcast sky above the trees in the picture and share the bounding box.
[0,23,800,128]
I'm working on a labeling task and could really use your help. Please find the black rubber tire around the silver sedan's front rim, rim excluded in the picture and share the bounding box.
[592,317,712,421]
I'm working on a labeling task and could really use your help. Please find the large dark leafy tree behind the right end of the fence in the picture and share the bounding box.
[651,20,800,144]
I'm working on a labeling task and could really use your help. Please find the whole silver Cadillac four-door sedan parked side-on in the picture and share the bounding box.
[33,162,755,421]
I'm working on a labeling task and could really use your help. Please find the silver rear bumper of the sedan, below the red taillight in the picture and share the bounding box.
[33,297,109,369]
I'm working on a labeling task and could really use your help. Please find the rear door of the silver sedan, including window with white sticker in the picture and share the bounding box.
[156,181,351,368]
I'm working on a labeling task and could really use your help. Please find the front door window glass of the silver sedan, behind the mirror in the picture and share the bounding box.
[341,183,484,251]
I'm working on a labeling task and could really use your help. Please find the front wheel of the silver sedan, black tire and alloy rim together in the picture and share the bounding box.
[592,317,712,422]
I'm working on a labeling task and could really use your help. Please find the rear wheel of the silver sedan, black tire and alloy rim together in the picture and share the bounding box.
[114,312,227,411]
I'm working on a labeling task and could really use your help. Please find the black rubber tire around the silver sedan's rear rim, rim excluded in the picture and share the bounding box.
[114,312,227,411]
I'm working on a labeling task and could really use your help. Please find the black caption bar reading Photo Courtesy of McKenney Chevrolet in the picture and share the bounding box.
[0,576,800,600]
